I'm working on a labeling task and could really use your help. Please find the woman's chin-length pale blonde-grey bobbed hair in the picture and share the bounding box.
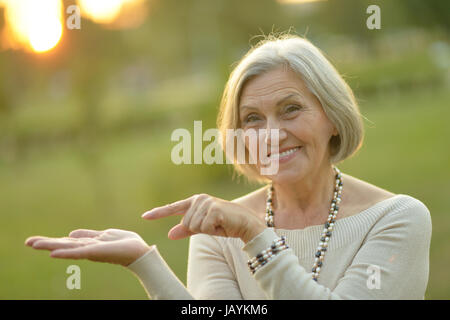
[217,34,364,182]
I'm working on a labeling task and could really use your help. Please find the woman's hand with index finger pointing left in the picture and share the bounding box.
[142,194,265,243]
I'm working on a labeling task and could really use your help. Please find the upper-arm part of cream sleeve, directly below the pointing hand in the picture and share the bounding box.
[187,234,243,300]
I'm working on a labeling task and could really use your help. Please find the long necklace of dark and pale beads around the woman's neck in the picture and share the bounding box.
[266,166,343,281]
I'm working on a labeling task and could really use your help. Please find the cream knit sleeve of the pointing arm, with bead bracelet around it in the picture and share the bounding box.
[243,199,431,300]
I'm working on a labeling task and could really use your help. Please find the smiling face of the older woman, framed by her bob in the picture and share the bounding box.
[239,67,337,183]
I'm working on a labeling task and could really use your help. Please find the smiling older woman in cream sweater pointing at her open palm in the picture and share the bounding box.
[26,35,431,299]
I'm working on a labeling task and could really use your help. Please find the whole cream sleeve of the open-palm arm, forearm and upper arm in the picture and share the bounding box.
[127,234,242,300]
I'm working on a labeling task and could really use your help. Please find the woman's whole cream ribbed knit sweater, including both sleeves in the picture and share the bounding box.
[128,194,432,300]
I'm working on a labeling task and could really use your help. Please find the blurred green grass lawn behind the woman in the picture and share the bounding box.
[0,84,450,299]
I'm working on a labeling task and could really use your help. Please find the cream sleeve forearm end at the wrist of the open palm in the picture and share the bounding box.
[127,246,193,300]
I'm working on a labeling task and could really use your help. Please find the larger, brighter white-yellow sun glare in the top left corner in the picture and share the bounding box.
[2,0,63,53]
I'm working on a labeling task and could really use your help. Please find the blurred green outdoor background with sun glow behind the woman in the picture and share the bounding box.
[0,0,450,299]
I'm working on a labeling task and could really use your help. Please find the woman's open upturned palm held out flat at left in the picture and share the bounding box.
[25,229,150,266]
